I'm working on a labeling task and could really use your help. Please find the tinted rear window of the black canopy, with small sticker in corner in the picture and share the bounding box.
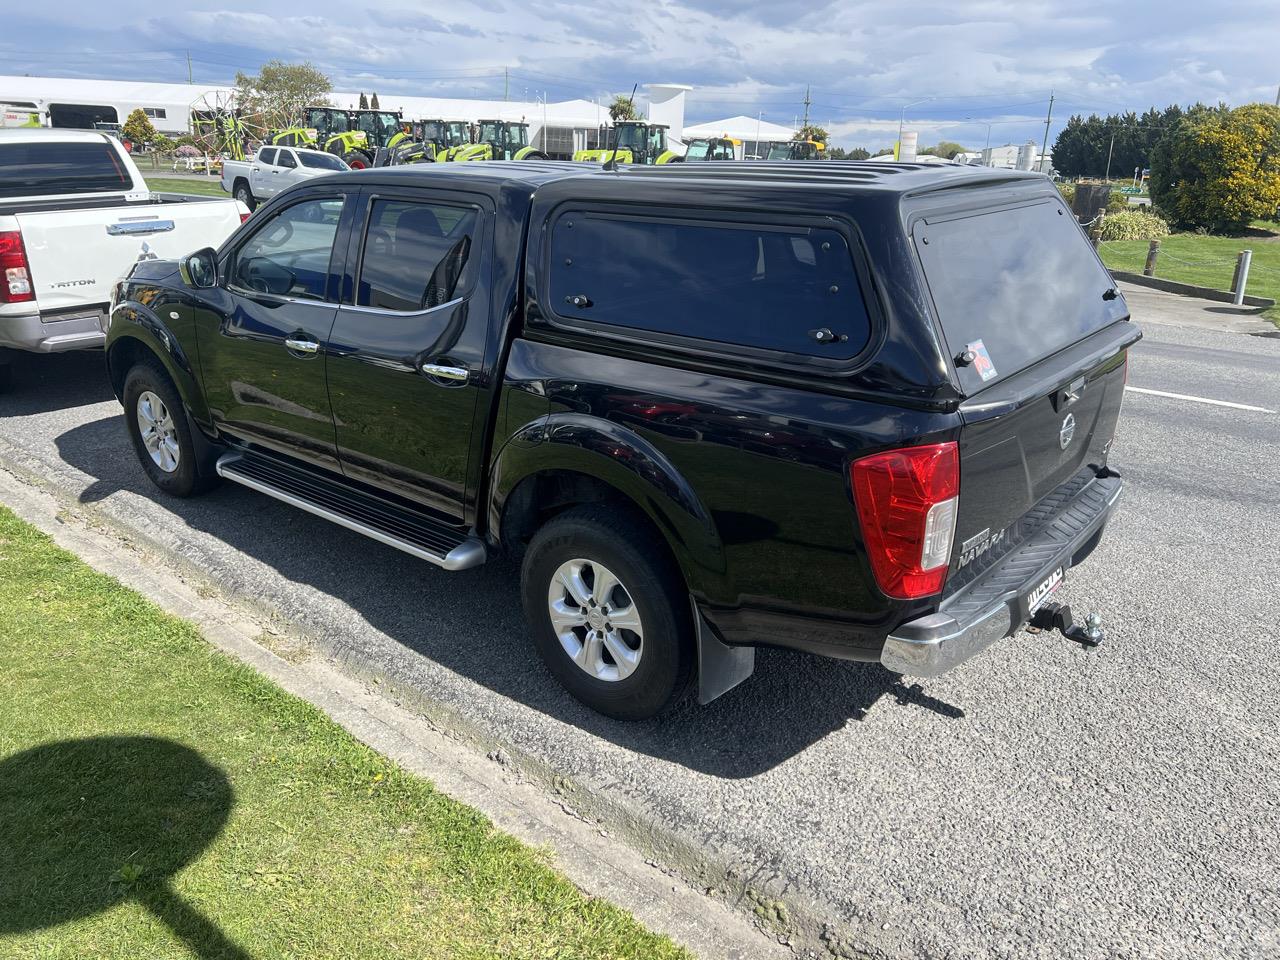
[914,201,1125,393]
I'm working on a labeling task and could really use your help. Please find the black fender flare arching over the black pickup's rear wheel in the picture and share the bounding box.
[488,413,727,596]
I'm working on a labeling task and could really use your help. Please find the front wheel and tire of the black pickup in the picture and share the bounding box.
[123,361,216,497]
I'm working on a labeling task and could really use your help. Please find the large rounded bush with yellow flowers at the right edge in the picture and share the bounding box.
[1151,104,1280,233]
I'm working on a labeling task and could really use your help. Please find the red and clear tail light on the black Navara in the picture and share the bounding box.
[850,443,960,600]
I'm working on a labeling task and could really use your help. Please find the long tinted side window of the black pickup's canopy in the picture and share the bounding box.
[550,212,869,360]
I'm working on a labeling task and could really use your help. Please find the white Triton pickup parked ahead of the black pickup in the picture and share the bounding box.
[0,129,248,389]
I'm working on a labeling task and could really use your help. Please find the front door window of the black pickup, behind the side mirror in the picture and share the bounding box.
[232,198,342,300]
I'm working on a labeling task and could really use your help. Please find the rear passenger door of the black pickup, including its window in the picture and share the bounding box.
[326,191,492,525]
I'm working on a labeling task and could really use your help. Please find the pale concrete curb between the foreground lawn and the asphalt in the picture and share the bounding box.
[0,436,870,960]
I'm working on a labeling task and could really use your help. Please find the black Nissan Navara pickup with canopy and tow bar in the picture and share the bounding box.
[106,161,1140,718]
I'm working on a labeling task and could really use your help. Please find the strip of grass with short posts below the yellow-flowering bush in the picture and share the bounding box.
[1098,220,1280,325]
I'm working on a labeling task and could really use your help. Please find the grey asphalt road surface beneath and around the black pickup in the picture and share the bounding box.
[0,297,1280,959]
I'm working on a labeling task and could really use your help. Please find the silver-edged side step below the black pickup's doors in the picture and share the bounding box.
[216,453,488,570]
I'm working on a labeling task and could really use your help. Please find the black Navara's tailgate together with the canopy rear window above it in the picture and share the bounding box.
[913,195,1140,586]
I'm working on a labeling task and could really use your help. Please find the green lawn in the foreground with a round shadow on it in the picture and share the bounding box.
[0,508,687,960]
